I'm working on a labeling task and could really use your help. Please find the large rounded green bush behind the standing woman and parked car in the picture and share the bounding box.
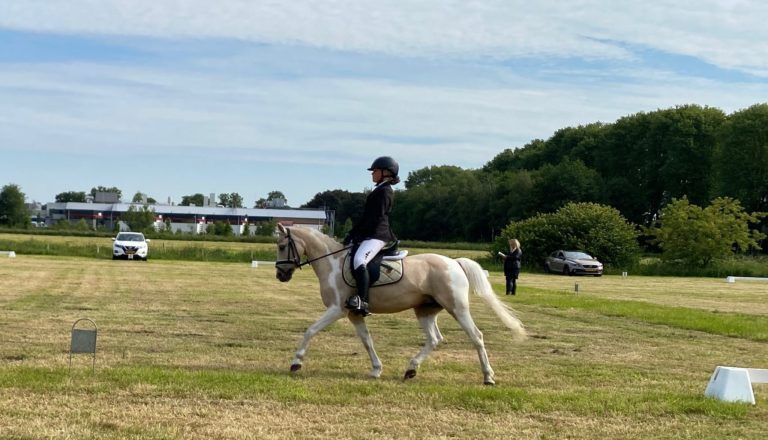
[492,203,639,267]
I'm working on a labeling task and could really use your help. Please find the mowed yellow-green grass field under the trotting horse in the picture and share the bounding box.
[0,255,768,439]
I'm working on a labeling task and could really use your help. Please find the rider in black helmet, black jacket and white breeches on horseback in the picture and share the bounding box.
[344,156,400,316]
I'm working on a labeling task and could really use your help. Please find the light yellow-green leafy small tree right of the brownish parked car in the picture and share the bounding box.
[647,197,765,267]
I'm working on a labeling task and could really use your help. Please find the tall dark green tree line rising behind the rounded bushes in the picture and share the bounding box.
[304,104,768,248]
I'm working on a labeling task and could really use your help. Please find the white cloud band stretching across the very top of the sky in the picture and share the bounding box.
[0,0,768,73]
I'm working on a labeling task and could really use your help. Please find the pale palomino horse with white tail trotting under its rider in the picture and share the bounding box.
[275,225,525,385]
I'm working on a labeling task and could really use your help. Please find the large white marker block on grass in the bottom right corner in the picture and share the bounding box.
[704,366,768,405]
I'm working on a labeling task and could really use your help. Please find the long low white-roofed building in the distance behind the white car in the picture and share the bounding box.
[45,202,333,235]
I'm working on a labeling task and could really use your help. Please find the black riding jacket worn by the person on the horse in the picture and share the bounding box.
[345,182,396,243]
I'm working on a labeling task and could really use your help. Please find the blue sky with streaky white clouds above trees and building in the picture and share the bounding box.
[0,0,768,207]
